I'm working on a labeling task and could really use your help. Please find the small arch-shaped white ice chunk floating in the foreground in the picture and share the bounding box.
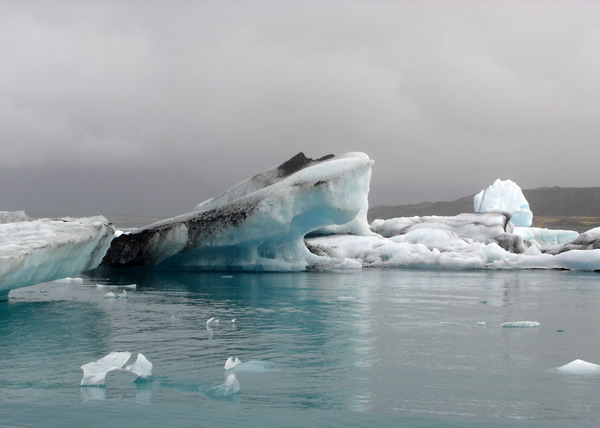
[81,351,152,386]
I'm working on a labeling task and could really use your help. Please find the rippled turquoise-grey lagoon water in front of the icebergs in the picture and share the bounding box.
[0,270,600,427]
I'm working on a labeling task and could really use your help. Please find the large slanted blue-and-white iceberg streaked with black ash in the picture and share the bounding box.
[103,153,373,271]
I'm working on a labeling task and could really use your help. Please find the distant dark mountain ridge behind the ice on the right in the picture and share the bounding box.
[368,186,600,221]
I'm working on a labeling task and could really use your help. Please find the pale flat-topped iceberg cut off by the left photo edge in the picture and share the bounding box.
[0,216,114,299]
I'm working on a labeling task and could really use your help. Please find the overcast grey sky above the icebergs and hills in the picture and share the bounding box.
[0,0,600,215]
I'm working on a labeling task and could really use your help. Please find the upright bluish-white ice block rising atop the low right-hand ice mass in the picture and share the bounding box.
[473,179,533,227]
